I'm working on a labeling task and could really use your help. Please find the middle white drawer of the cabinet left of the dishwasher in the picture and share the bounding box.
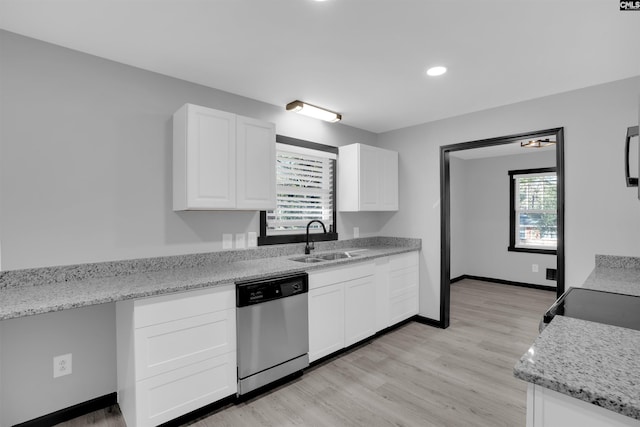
[134,308,236,380]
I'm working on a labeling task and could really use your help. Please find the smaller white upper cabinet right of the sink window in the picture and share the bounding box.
[338,144,398,212]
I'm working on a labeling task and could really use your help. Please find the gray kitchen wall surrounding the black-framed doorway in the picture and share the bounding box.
[378,76,640,319]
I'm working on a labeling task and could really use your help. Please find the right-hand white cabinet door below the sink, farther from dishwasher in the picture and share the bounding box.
[344,276,376,347]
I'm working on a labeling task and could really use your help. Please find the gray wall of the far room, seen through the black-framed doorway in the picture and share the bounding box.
[450,149,556,286]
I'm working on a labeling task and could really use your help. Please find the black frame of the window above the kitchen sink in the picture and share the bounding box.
[258,135,339,246]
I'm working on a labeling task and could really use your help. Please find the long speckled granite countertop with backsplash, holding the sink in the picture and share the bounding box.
[0,238,421,320]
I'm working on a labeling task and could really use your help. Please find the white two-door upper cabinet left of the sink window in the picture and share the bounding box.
[173,104,276,211]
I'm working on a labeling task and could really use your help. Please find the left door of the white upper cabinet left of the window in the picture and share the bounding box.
[174,105,236,210]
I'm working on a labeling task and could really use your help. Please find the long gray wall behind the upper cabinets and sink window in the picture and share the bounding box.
[0,31,386,426]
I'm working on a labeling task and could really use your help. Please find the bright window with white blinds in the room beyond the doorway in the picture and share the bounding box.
[513,172,558,249]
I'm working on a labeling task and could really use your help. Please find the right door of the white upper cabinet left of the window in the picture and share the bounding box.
[236,116,276,210]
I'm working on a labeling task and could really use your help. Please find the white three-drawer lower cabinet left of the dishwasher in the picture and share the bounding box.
[116,285,237,427]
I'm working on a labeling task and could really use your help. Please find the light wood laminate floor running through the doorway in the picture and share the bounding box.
[60,279,555,427]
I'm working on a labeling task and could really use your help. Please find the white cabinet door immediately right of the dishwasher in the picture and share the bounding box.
[309,283,344,361]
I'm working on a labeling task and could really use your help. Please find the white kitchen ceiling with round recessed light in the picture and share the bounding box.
[0,0,640,133]
